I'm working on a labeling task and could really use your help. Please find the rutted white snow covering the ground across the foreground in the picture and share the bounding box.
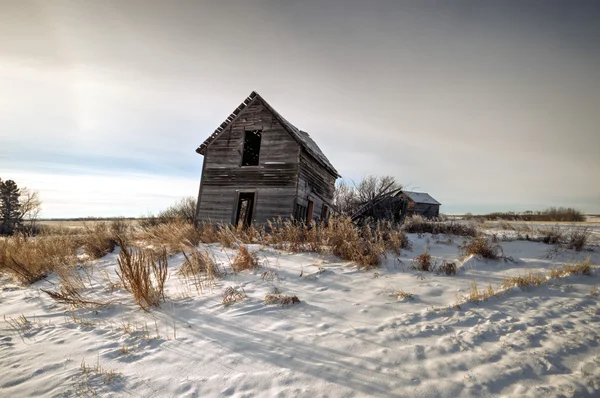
[0,234,600,397]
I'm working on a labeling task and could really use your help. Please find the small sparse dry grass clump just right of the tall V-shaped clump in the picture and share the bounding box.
[178,248,223,294]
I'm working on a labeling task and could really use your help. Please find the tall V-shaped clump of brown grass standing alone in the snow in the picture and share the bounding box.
[117,236,168,311]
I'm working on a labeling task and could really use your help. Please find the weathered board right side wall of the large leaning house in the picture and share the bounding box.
[296,151,336,220]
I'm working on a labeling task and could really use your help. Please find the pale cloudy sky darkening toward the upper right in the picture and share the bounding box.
[0,0,600,217]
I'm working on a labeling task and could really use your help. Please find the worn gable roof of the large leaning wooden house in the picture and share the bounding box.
[196,91,341,177]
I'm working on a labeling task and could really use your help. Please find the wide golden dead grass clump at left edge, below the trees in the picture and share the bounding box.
[0,234,78,285]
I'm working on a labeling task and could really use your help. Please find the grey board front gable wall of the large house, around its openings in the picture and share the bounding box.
[198,100,300,224]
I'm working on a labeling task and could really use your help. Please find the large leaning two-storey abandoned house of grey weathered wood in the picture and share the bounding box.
[196,91,340,225]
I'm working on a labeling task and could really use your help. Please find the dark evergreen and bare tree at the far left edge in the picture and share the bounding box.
[0,179,41,235]
